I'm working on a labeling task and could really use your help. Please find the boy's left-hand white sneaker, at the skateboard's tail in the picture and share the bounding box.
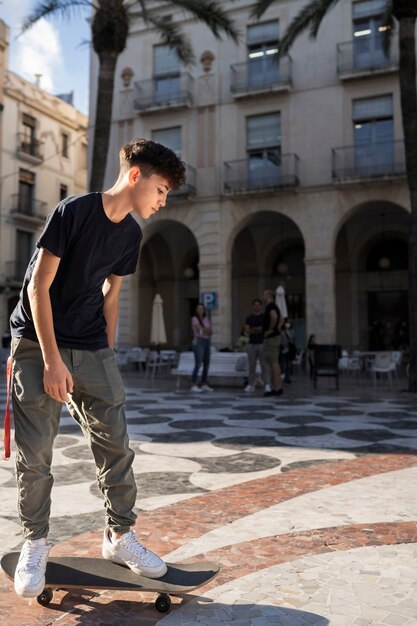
[14,538,52,598]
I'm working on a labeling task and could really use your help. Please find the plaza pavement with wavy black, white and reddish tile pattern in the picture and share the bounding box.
[0,373,417,626]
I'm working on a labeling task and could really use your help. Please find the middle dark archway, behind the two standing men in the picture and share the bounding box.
[232,211,306,348]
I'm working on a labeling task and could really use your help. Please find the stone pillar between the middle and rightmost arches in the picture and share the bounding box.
[305,257,336,343]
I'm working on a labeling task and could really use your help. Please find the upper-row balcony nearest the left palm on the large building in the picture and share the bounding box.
[134,73,193,114]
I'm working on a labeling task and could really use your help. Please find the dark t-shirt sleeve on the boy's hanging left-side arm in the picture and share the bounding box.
[36,203,75,258]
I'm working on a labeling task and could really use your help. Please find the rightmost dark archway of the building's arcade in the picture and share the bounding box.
[336,201,410,350]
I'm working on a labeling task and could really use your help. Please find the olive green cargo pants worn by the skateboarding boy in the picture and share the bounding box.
[11,338,137,539]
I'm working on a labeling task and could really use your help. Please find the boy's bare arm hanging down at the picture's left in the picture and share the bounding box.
[28,249,73,402]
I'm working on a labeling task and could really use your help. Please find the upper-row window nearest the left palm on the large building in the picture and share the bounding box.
[153,45,180,102]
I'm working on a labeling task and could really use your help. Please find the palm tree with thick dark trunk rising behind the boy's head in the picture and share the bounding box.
[22,0,238,191]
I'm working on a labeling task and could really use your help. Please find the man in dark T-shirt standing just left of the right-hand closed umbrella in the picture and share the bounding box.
[263,289,284,396]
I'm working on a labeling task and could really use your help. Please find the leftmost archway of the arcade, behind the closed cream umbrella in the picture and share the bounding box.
[138,220,199,350]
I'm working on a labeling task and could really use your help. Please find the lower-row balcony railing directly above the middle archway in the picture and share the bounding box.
[224,154,299,194]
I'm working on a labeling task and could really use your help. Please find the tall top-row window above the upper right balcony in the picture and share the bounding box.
[352,0,388,68]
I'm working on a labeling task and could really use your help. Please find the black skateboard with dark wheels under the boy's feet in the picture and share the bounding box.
[0,552,220,613]
